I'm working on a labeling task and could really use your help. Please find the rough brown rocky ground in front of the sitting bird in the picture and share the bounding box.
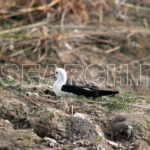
[0,85,150,150]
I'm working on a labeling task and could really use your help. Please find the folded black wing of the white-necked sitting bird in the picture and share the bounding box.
[61,84,119,98]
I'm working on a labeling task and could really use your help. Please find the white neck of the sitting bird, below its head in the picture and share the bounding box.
[53,75,67,96]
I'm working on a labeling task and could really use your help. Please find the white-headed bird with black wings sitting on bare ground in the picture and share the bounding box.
[50,68,119,98]
